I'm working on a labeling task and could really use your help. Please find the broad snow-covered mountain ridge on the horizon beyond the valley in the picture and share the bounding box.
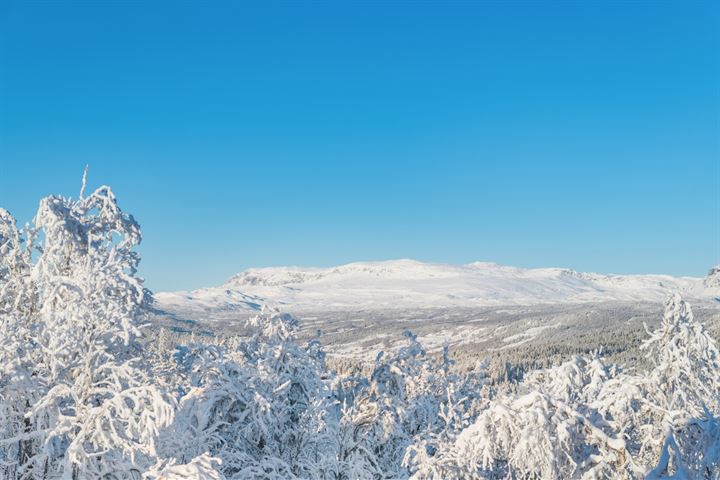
[155,260,720,312]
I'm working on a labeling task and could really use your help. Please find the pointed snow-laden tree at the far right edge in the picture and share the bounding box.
[640,294,720,478]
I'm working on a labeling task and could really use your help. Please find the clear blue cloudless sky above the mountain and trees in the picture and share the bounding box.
[0,0,720,290]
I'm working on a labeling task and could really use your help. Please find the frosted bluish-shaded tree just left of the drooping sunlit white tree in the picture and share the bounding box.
[342,332,482,478]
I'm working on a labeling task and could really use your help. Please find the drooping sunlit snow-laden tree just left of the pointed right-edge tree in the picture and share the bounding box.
[416,357,627,479]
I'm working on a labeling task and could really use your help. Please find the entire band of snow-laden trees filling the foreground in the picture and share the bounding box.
[0,176,720,480]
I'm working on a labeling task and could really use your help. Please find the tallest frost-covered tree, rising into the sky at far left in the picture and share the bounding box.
[0,174,214,479]
